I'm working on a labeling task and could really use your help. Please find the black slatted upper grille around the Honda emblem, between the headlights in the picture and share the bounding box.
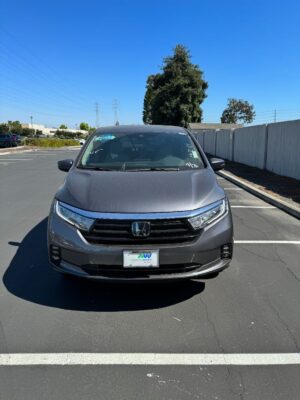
[81,219,199,245]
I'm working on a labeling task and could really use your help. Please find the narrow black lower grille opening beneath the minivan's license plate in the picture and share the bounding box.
[81,263,201,278]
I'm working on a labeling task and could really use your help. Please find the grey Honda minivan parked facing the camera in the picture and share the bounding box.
[48,125,233,281]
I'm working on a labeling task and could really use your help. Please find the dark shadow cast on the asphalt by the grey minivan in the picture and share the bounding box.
[3,218,205,312]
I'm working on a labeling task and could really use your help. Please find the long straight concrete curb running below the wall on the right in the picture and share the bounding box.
[217,171,300,219]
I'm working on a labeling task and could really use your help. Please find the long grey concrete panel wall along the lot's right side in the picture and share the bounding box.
[196,120,300,179]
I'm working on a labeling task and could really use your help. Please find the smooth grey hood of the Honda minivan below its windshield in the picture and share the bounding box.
[56,168,225,213]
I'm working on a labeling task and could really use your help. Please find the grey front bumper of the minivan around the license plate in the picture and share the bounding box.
[48,210,233,282]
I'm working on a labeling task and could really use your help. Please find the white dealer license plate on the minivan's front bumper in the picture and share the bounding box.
[123,250,159,268]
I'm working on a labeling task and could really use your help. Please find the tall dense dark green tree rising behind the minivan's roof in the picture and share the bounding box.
[143,45,208,126]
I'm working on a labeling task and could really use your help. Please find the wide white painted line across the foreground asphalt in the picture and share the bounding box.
[0,353,300,366]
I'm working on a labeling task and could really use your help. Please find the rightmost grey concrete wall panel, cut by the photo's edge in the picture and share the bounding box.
[266,120,300,179]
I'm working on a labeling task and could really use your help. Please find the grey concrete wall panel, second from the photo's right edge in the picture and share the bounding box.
[233,125,267,169]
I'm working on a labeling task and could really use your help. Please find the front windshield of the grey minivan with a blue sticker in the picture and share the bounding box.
[78,130,204,171]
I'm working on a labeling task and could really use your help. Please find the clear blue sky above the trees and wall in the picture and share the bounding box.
[0,0,300,126]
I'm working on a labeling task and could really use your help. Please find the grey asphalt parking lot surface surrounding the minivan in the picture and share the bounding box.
[0,150,300,400]
